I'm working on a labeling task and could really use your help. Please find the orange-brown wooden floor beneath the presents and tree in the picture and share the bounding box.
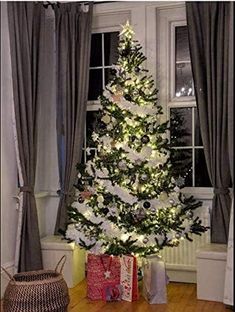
[68,281,231,312]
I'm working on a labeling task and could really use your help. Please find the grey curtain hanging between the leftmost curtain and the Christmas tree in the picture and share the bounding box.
[55,3,93,234]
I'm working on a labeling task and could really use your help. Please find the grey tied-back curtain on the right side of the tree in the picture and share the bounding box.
[186,2,233,243]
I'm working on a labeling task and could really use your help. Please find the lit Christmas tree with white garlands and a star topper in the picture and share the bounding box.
[66,22,207,256]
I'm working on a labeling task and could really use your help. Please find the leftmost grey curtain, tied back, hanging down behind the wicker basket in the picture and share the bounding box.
[6,2,44,272]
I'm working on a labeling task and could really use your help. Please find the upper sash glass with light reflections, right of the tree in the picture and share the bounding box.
[175,26,193,97]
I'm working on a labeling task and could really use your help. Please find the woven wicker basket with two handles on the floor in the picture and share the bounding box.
[2,256,69,312]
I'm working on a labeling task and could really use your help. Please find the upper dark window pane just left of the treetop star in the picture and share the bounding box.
[104,32,119,66]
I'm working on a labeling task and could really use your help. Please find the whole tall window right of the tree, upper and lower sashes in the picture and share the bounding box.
[168,23,211,187]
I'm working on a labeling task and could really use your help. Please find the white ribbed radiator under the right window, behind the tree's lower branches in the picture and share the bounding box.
[160,207,210,283]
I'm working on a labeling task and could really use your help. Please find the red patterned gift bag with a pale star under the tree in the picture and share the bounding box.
[87,254,120,300]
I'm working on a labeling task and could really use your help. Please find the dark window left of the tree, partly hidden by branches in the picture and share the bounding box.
[82,31,119,163]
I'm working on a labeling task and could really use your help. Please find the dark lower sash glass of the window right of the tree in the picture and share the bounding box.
[170,107,211,187]
